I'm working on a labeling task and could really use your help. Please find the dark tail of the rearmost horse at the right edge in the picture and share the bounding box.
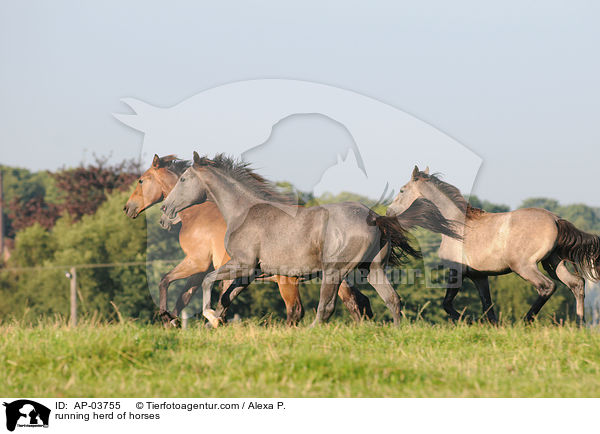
[556,219,600,282]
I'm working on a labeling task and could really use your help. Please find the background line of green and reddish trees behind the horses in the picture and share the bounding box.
[0,158,600,322]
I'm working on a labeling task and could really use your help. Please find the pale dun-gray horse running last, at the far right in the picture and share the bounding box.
[387,166,600,323]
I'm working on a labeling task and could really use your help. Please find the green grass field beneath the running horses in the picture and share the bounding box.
[0,322,600,397]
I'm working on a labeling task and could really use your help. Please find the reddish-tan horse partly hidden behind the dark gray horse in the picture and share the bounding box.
[123,155,373,325]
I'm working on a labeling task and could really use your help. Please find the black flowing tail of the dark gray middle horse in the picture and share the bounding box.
[368,199,462,265]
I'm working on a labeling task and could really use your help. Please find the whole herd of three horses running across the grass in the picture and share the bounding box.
[124,152,600,327]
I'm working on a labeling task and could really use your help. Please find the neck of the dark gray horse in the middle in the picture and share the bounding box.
[203,170,265,228]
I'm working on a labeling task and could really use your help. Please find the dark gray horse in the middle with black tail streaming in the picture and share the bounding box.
[163,152,457,327]
